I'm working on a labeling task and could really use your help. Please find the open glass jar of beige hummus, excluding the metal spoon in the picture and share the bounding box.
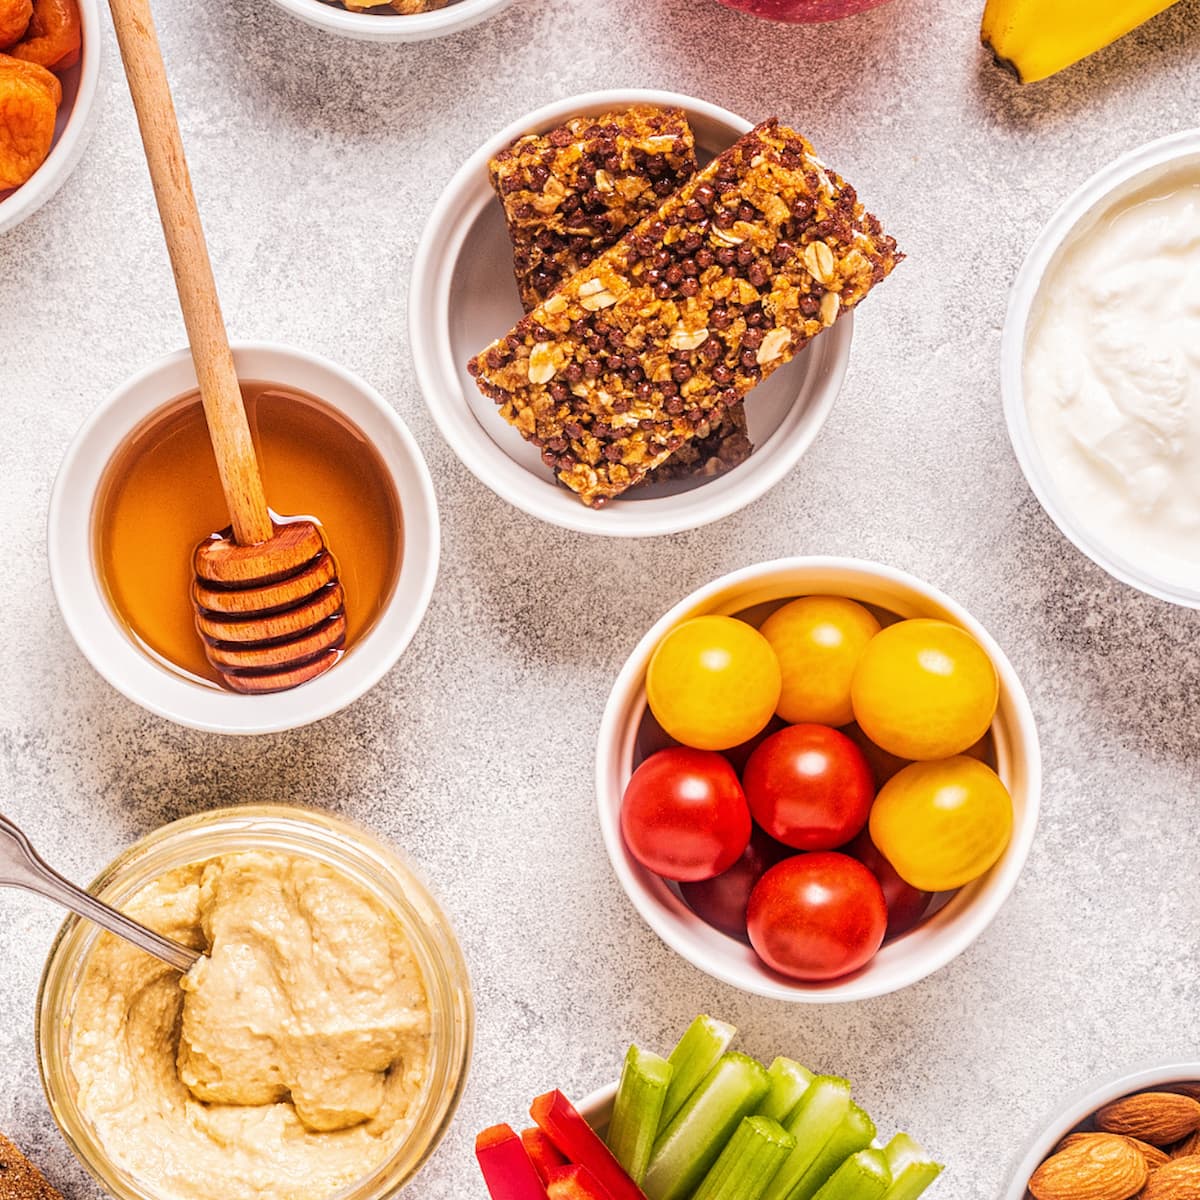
[37,805,474,1200]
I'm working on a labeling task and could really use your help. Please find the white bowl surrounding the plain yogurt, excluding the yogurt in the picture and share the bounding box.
[1000,128,1200,608]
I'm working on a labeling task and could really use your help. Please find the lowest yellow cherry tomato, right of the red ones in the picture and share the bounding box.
[870,755,1013,892]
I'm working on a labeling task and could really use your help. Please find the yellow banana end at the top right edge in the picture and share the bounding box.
[979,0,1176,83]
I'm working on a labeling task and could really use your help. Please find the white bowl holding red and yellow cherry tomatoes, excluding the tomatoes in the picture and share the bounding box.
[596,558,1042,1003]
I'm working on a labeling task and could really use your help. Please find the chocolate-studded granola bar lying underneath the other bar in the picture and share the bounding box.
[487,104,754,480]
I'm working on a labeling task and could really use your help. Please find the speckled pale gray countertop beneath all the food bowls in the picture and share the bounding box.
[0,0,1200,1200]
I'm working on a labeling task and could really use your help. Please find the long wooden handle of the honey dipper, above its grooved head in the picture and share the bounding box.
[109,0,274,546]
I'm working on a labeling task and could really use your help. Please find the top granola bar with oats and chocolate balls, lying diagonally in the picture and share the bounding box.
[469,119,902,506]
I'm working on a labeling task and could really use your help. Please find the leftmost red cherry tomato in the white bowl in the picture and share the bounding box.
[620,746,751,881]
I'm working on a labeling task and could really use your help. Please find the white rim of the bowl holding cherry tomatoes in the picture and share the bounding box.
[595,556,1042,1004]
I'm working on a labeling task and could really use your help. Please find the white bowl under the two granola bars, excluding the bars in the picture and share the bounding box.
[408,90,853,538]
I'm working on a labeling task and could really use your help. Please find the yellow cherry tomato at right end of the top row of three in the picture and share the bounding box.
[850,618,1000,760]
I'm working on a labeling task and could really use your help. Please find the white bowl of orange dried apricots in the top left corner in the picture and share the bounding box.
[0,0,101,233]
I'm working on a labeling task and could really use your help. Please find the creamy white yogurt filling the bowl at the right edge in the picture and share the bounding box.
[1024,170,1200,589]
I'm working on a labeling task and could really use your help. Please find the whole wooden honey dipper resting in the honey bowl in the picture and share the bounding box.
[109,0,346,692]
